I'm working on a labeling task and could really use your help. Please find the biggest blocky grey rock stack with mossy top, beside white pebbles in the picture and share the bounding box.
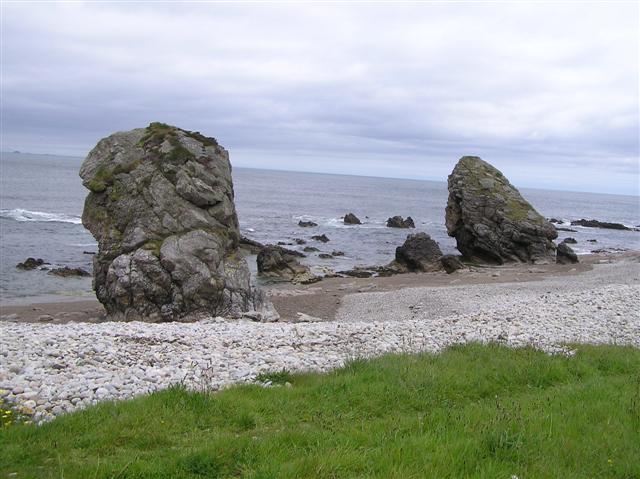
[80,123,264,321]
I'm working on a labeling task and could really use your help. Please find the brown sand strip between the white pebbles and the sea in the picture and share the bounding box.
[0,251,640,324]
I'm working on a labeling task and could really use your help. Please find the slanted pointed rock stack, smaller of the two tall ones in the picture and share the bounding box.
[445,156,558,264]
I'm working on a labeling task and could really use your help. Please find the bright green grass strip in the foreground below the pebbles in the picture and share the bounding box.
[0,344,640,479]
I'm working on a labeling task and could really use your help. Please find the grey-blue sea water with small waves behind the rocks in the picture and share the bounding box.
[0,153,640,304]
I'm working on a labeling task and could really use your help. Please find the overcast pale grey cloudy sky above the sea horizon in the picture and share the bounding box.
[0,0,640,195]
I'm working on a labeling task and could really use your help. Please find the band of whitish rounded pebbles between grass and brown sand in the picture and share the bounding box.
[0,254,640,422]
